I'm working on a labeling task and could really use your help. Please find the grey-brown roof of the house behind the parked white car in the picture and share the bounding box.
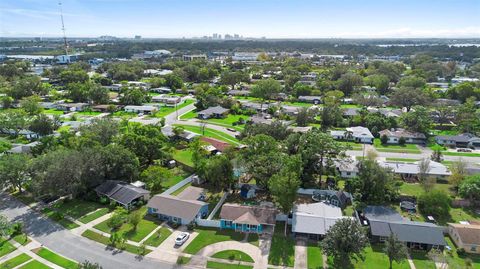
[147,194,208,222]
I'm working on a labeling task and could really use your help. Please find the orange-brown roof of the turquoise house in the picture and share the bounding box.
[220,203,277,225]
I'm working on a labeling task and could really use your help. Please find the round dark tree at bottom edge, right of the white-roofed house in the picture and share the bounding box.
[321,218,368,268]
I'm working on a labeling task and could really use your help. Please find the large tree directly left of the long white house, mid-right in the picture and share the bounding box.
[298,130,347,183]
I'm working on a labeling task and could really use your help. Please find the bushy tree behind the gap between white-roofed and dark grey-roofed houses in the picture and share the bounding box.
[345,159,398,204]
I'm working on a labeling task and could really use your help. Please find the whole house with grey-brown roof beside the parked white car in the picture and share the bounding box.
[147,186,208,225]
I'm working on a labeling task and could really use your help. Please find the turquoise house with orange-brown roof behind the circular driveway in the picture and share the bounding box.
[220,203,277,233]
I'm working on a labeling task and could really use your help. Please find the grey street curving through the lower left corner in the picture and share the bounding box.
[0,192,193,269]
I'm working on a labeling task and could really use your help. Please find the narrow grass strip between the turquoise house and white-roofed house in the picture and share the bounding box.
[268,222,295,267]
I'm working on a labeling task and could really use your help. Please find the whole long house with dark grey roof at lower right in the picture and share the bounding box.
[359,206,447,251]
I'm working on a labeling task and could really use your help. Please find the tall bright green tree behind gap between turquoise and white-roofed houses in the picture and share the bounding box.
[268,155,302,236]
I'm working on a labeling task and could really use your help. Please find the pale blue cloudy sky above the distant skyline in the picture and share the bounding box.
[0,0,480,38]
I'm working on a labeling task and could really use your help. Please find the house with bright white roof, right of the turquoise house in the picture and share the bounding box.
[292,202,344,240]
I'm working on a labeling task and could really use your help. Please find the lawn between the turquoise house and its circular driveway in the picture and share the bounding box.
[184,228,244,254]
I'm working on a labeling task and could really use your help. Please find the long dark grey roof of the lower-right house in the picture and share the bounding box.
[370,220,446,246]
